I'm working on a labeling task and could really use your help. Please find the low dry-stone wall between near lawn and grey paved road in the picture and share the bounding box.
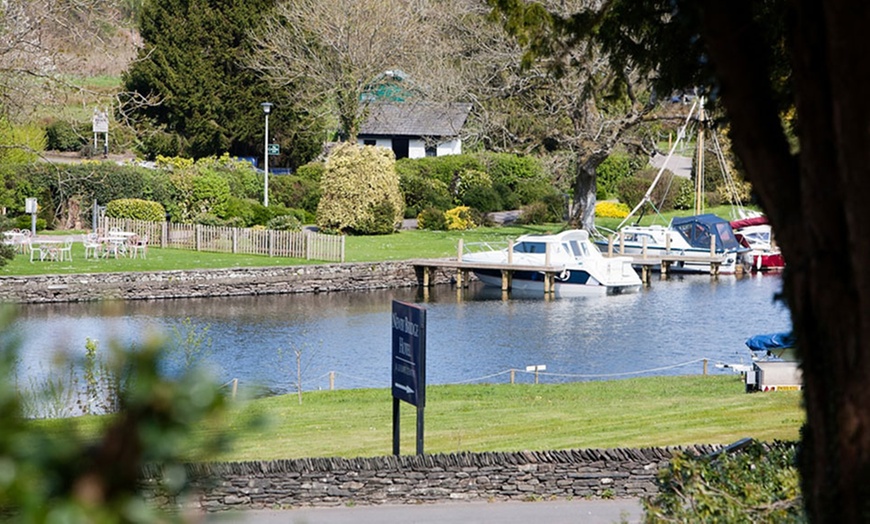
[146,446,721,511]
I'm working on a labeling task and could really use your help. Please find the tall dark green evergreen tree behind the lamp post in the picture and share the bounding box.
[124,0,320,165]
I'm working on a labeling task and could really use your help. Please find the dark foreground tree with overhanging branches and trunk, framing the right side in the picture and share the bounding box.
[490,0,870,522]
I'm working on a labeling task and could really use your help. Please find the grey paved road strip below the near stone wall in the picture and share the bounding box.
[207,499,643,524]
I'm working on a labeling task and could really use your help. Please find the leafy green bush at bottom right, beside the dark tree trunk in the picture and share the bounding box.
[644,442,806,524]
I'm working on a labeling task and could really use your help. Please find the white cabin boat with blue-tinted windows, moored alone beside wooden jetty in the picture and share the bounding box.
[462,229,641,297]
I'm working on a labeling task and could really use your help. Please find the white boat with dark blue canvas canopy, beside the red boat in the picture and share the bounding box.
[596,213,749,274]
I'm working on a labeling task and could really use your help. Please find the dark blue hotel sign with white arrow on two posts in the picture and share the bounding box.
[391,300,426,455]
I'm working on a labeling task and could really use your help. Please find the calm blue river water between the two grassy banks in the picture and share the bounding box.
[15,275,791,392]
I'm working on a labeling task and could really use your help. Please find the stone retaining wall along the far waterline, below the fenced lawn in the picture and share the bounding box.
[0,262,453,303]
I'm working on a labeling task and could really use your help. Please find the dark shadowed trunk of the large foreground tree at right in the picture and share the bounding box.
[702,0,870,522]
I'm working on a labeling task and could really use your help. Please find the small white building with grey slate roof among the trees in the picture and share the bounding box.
[357,102,471,160]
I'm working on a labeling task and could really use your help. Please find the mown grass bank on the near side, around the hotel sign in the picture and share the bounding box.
[164,376,804,461]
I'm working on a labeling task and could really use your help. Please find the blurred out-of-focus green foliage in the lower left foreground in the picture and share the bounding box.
[0,315,235,523]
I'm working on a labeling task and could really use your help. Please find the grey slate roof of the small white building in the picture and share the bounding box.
[359,102,471,136]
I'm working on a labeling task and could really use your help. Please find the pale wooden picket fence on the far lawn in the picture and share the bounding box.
[100,217,344,262]
